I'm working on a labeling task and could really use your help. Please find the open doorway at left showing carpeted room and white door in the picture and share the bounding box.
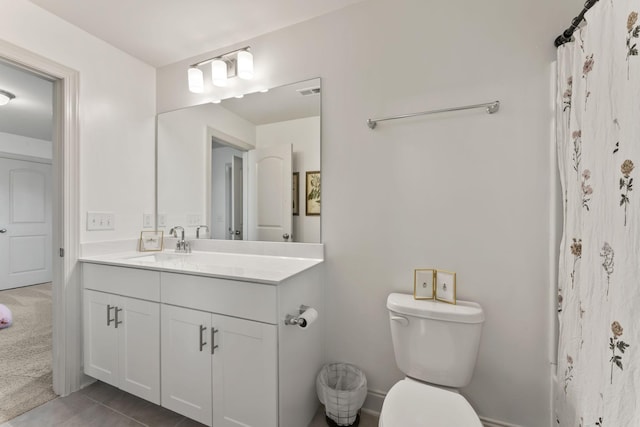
[0,61,56,423]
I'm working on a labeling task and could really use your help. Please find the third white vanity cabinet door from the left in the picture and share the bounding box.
[160,304,211,426]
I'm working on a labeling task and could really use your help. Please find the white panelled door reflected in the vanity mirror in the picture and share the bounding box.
[247,144,293,242]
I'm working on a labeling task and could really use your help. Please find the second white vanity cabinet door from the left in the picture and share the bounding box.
[116,297,160,404]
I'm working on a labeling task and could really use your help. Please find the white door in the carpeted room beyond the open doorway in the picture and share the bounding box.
[0,158,53,290]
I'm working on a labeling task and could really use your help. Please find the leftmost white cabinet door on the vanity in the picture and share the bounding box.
[84,289,118,387]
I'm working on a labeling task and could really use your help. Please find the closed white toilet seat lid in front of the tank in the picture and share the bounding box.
[378,379,482,427]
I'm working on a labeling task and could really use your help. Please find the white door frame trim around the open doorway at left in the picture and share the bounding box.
[0,40,82,396]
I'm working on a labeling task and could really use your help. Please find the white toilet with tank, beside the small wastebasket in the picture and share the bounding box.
[378,293,484,427]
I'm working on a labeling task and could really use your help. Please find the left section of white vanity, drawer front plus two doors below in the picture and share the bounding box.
[83,264,160,404]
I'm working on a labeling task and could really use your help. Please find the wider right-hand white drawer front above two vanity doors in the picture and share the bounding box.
[161,272,278,325]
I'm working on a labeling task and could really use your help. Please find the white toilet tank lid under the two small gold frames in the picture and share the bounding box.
[387,293,484,323]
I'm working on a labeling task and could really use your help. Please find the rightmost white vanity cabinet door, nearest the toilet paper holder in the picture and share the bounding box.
[211,314,278,427]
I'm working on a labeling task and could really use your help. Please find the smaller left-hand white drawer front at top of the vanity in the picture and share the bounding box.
[82,263,160,302]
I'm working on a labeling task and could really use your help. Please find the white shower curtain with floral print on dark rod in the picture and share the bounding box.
[555,0,640,427]
